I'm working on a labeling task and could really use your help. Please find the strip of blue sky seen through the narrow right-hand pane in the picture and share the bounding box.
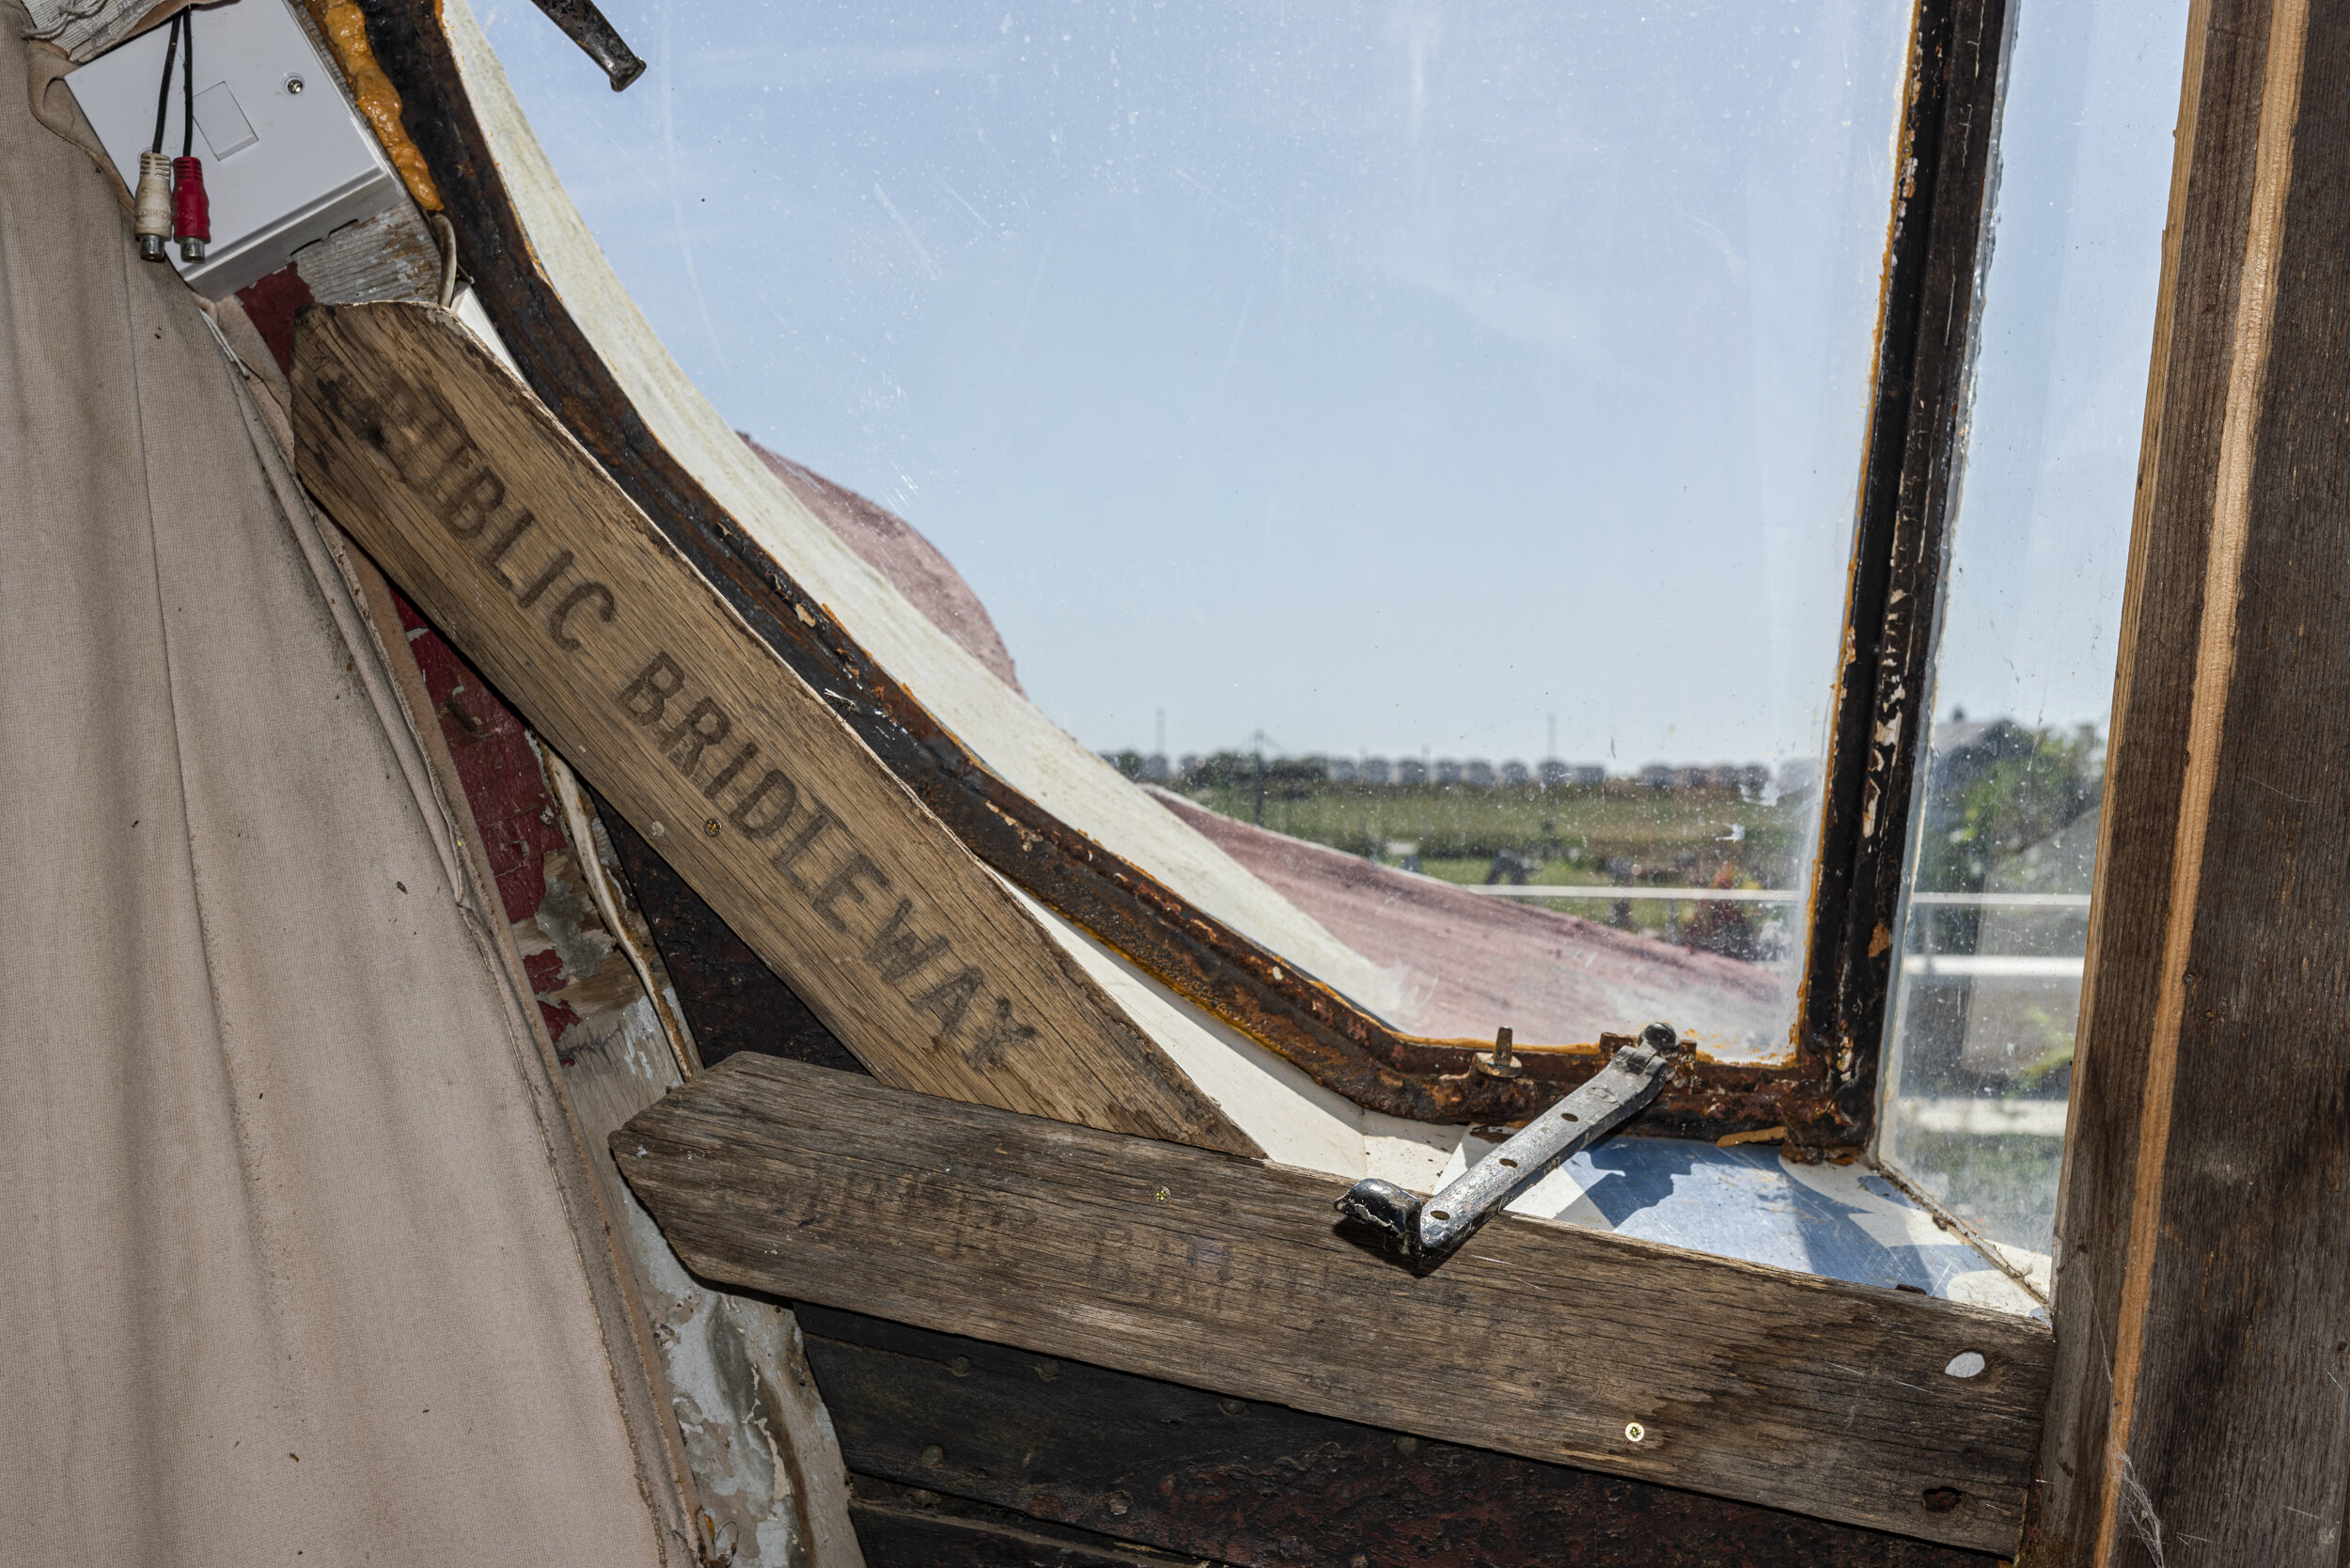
[1935,0,2188,752]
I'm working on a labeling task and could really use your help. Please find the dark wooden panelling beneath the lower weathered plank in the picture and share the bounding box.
[799,1305,1998,1568]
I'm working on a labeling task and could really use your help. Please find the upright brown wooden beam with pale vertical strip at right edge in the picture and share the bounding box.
[2026,0,2350,1568]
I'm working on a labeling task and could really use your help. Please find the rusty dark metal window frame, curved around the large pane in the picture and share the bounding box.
[343,0,2010,1145]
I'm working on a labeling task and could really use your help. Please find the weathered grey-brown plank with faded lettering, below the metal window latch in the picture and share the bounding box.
[614,1056,2049,1551]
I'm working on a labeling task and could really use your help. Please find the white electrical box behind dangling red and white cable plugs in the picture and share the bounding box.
[66,0,402,299]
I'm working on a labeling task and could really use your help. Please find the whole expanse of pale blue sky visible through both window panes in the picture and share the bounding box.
[484,0,2184,769]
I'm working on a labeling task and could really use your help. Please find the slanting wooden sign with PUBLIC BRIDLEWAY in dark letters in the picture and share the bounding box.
[294,304,1260,1154]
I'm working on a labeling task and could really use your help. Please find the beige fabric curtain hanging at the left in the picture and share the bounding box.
[0,8,686,1568]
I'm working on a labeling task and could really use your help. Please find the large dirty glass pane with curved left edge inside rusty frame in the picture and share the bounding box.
[482,0,1911,1053]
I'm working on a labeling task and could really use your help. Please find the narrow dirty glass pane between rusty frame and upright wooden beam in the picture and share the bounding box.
[1880,0,2188,1267]
